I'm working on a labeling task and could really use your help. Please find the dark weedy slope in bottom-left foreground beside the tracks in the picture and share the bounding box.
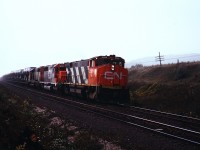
[0,87,104,150]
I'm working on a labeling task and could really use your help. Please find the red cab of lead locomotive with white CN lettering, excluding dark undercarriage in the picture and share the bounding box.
[88,55,128,88]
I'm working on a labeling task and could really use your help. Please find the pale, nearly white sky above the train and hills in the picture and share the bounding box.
[0,0,200,76]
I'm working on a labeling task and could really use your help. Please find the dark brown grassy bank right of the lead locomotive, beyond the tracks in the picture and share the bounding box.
[128,62,200,117]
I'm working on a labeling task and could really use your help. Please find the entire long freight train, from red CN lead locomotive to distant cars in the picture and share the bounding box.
[2,55,129,103]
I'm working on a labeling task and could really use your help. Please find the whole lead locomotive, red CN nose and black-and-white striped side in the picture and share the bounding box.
[64,55,129,102]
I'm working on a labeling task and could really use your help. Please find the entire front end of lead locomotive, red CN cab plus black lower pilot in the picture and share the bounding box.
[88,55,129,103]
